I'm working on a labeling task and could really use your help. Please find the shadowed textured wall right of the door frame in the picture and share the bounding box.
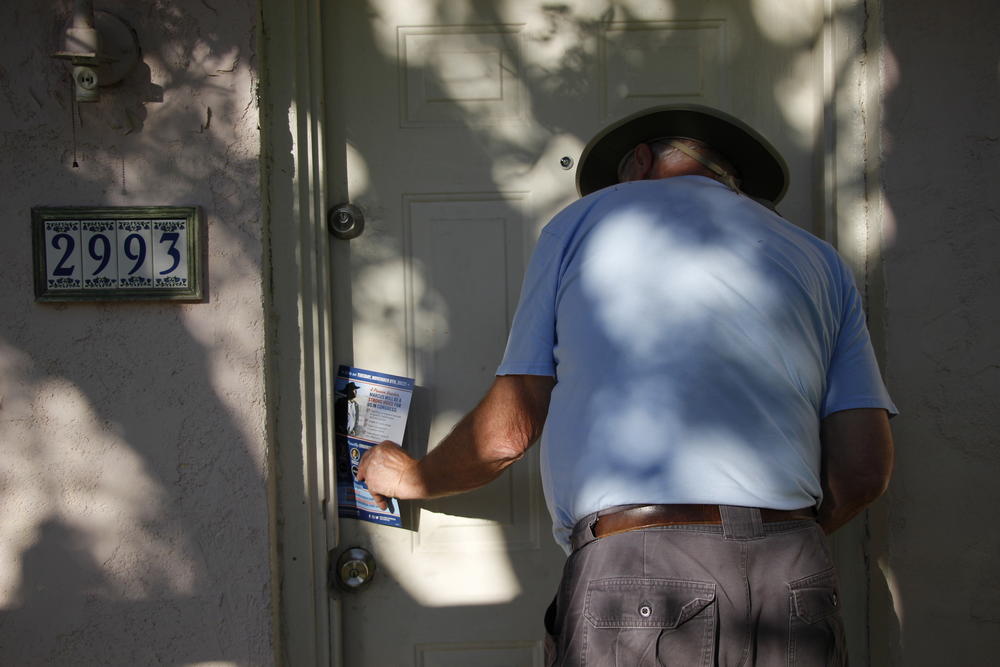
[876,0,1000,666]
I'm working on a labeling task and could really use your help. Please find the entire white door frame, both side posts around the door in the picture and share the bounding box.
[258,0,892,667]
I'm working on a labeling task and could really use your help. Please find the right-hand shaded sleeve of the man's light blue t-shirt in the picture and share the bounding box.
[820,264,899,417]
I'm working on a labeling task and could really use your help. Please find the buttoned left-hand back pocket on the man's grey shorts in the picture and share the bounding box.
[581,577,716,667]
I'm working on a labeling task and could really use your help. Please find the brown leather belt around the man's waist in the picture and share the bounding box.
[591,505,816,538]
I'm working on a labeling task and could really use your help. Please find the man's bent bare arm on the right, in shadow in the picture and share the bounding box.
[819,408,893,534]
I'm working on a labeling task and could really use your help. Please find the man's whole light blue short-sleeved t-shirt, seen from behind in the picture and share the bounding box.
[497,176,895,549]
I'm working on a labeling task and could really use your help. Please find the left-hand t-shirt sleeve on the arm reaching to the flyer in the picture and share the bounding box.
[497,231,561,377]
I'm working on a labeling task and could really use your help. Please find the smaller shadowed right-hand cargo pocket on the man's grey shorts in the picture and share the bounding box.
[788,570,847,667]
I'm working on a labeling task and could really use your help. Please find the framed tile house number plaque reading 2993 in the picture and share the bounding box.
[31,206,202,301]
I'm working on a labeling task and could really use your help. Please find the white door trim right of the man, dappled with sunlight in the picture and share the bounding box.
[823,0,889,665]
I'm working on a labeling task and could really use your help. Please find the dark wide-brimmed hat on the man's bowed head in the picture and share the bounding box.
[576,104,788,204]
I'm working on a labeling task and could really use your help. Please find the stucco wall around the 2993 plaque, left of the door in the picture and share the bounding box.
[0,0,273,666]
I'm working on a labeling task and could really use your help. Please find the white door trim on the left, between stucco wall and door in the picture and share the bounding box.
[260,0,341,667]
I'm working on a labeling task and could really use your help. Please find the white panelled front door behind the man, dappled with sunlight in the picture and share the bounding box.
[324,0,824,666]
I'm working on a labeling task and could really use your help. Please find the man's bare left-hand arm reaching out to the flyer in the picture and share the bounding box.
[358,375,555,507]
